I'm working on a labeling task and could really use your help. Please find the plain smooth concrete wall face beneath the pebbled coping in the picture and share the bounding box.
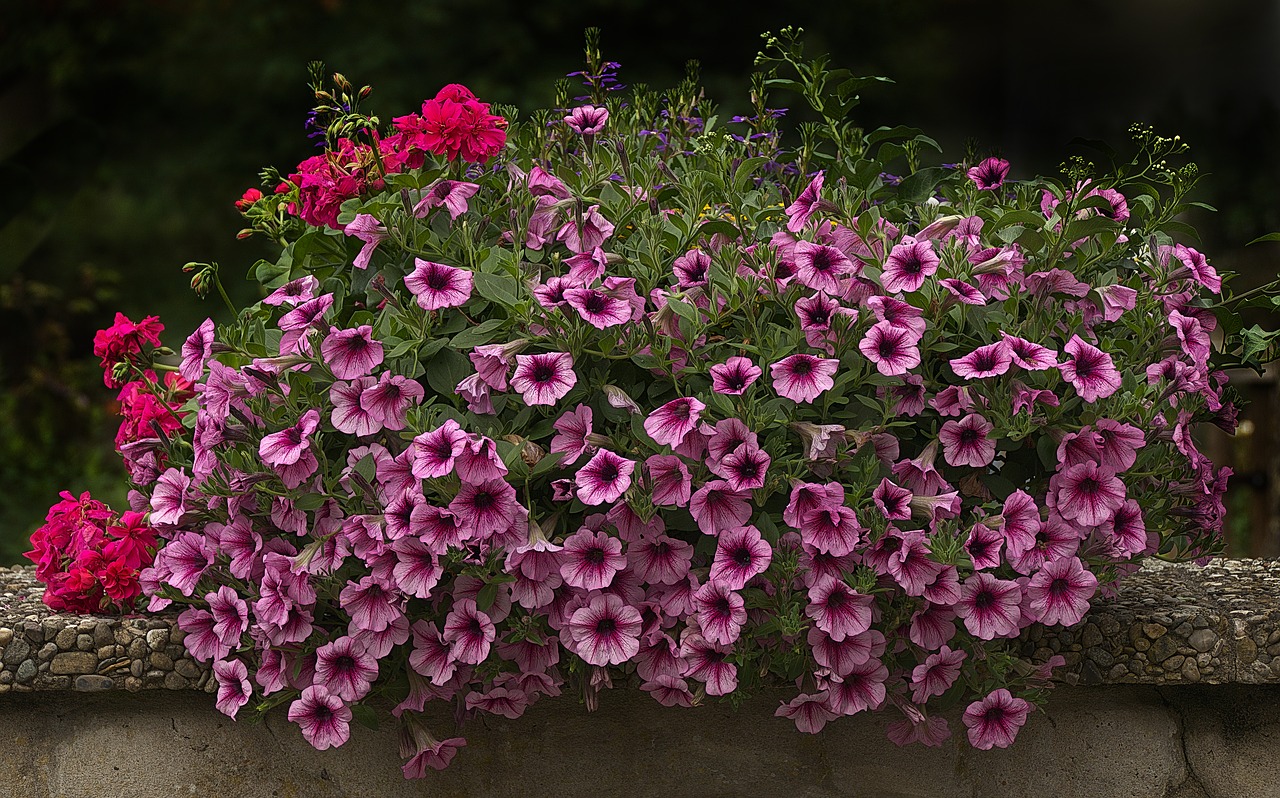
[0,685,1280,798]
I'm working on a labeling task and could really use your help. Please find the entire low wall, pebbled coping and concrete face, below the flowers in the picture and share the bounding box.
[0,561,1280,798]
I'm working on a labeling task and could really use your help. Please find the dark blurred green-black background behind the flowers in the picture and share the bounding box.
[0,0,1280,562]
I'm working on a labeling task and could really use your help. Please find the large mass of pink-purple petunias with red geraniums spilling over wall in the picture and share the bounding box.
[30,31,1270,776]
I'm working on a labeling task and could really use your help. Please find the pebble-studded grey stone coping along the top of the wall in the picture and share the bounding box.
[0,558,1280,693]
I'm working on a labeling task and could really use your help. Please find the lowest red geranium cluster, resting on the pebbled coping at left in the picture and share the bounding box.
[23,491,156,612]
